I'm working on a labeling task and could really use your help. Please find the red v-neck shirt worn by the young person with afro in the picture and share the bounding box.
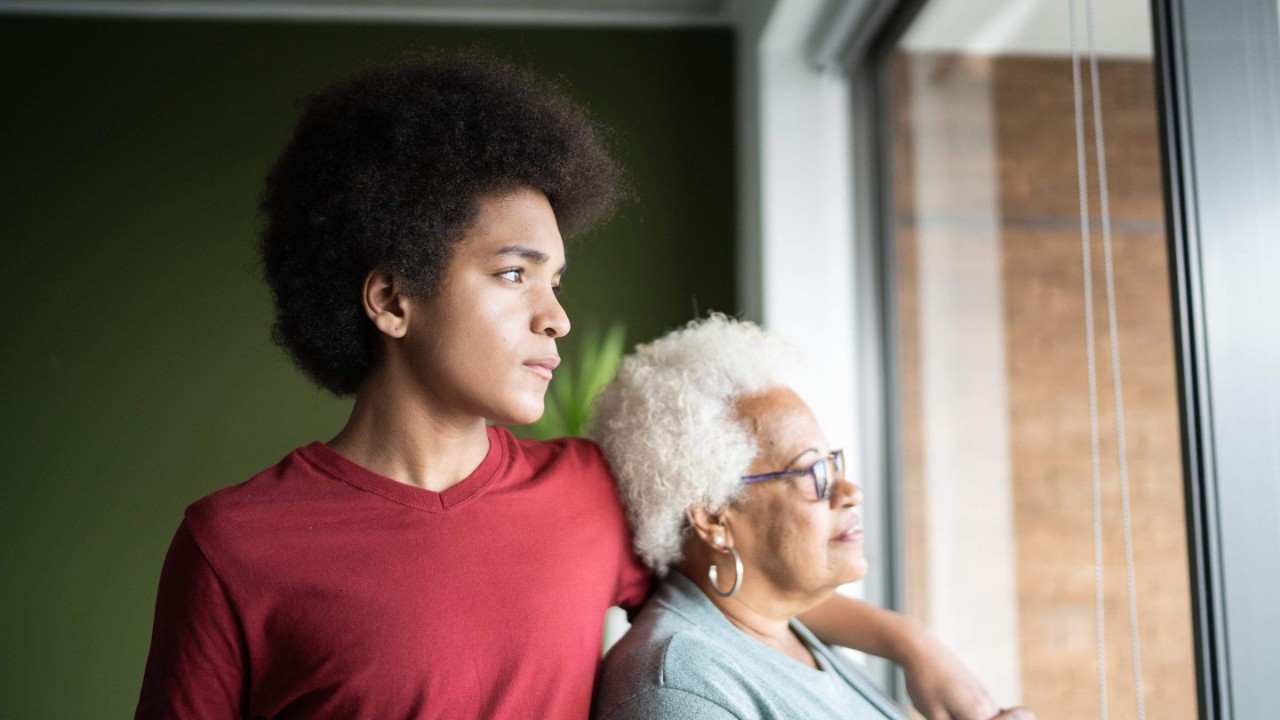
[137,428,649,719]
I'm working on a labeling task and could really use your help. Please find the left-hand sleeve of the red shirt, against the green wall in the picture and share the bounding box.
[134,521,247,720]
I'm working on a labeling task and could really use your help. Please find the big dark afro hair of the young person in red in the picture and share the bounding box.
[261,53,623,396]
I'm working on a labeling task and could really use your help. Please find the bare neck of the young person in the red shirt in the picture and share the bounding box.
[328,366,489,492]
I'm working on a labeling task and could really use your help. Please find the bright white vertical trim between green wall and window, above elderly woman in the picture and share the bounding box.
[756,0,860,596]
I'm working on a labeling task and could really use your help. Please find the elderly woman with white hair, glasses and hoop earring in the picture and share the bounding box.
[593,315,1030,720]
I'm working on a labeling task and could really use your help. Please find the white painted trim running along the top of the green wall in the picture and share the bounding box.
[0,0,733,28]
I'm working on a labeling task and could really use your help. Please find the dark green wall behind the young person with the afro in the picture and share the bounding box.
[0,17,735,717]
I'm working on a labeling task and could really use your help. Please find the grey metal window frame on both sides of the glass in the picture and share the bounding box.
[829,0,1280,720]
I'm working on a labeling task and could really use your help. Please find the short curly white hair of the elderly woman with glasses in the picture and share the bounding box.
[589,314,800,575]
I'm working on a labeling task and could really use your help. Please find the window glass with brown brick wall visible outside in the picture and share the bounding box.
[886,0,1197,720]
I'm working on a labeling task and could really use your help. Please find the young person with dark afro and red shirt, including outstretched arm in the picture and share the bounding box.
[137,56,996,719]
